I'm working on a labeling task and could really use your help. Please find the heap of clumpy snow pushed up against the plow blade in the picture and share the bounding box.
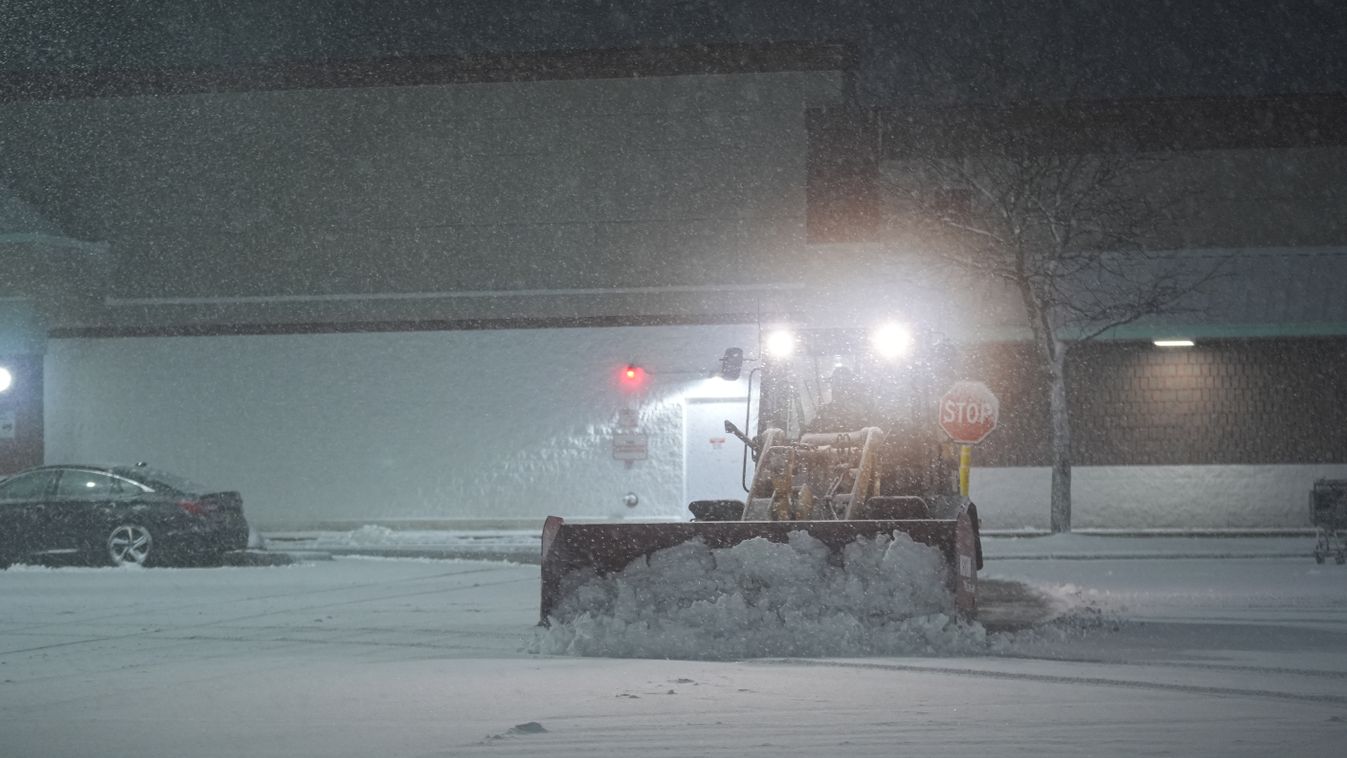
[533,532,986,660]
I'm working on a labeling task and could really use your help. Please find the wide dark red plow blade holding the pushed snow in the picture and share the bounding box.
[539,505,982,625]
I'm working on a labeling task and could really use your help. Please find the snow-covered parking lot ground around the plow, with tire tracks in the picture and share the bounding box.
[0,547,1347,758]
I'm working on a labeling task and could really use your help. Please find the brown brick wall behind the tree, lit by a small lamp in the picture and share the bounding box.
[964,338,1347,466]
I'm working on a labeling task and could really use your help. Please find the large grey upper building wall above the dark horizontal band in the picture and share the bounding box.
[0,65,841,324]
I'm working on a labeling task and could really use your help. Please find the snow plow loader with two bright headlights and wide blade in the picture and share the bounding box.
[540,330,982,625]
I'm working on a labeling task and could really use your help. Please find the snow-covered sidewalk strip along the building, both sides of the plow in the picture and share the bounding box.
[263,525,1315,563]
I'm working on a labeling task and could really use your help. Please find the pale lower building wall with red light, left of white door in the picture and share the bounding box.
[46,327,757,529]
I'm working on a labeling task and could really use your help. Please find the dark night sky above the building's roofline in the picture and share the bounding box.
[0,0,1347,101]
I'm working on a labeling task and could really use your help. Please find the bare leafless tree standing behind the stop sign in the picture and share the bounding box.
[909,144,1218,532]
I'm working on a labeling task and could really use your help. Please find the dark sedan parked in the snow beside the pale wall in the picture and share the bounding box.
[0,466,248,567]
